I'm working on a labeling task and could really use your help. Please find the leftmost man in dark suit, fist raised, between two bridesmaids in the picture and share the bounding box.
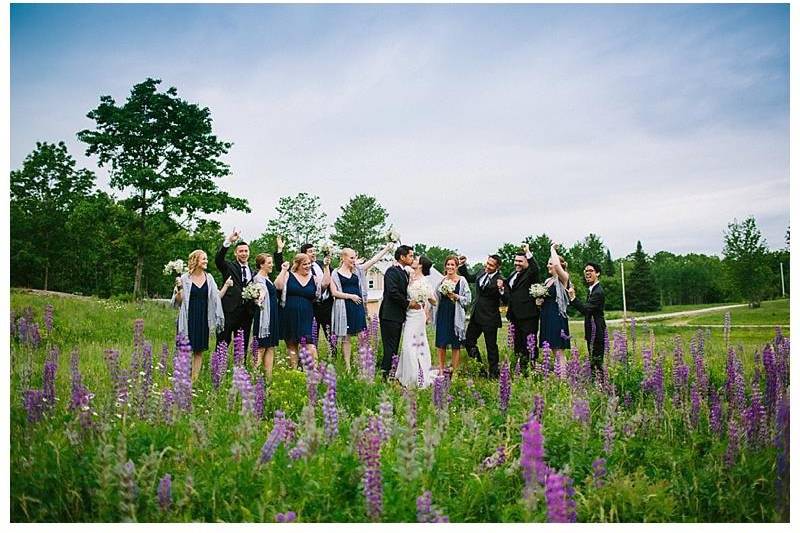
[214,230,283,354]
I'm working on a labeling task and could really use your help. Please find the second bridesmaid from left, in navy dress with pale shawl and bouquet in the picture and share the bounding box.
[253,254,280,378]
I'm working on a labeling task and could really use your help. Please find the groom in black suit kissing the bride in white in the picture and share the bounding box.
[378,244,420,379]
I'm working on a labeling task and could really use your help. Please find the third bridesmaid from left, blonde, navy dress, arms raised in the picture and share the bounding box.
[275,253,331,368]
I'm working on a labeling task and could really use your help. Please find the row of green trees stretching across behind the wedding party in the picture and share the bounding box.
[10,78,789,310]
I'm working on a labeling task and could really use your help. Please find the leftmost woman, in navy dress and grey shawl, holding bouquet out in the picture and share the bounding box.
[171,250,227,382]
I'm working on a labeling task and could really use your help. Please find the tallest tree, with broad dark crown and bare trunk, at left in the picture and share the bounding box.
[78,78,250,297]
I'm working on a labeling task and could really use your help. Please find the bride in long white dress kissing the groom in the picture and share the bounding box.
[395,257,441,389]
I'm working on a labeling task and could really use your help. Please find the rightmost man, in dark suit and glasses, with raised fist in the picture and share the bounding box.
[567,262,606,375]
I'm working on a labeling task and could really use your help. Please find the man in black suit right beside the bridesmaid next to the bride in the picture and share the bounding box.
[458,255,503,378]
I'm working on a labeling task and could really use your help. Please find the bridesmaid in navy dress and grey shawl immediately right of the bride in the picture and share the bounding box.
[434,255,472,373]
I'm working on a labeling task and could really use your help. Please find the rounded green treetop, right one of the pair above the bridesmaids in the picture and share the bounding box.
[331,194,389,257]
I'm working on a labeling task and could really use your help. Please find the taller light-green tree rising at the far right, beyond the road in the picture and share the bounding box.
[722,216,770,307]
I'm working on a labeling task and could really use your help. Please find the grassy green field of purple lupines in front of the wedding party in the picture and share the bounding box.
[10,291,790,522]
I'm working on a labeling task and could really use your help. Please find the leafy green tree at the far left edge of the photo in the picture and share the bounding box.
[10,142,95,290]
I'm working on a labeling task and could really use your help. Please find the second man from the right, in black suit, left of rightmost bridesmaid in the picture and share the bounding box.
[500,243,539,369]
